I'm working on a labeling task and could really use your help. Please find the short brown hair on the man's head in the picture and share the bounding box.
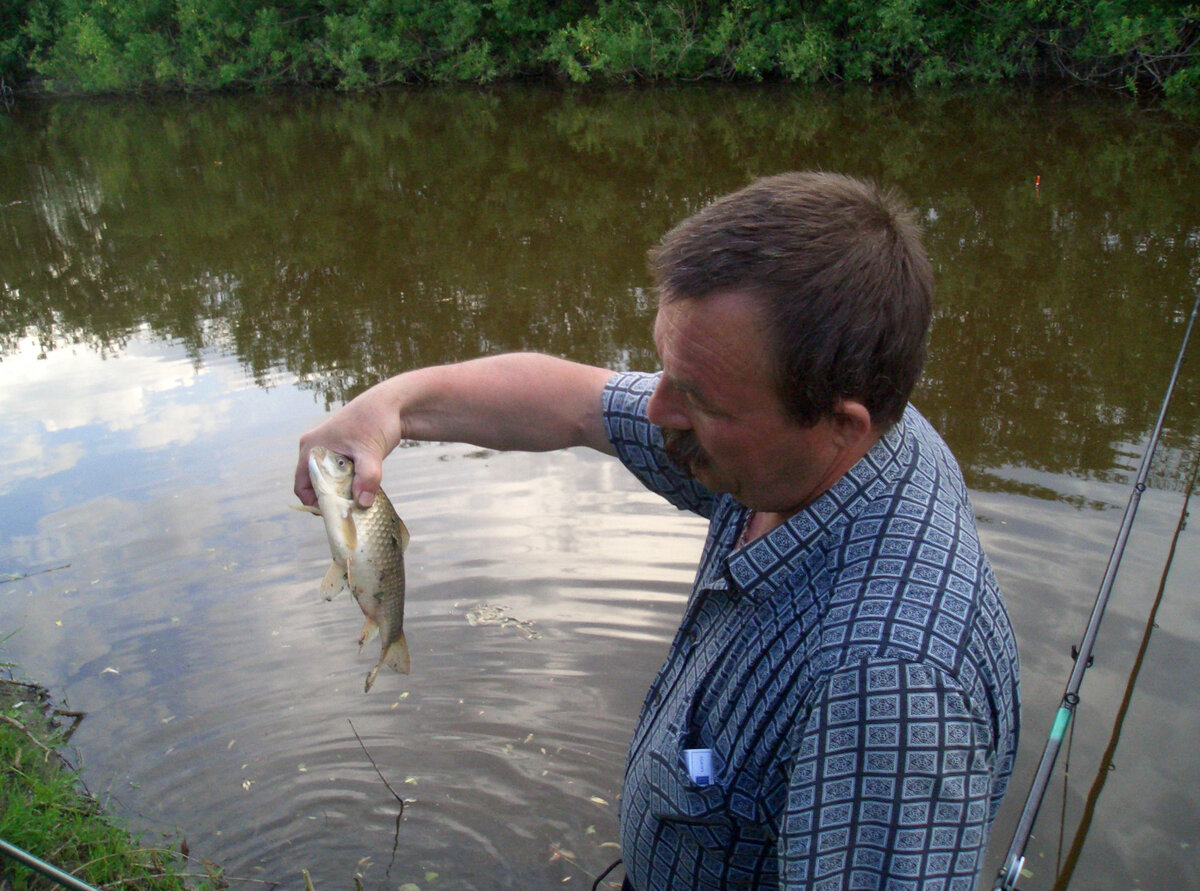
[649,173,934,427]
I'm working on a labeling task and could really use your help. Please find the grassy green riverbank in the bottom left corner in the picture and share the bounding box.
[0,666,220,891]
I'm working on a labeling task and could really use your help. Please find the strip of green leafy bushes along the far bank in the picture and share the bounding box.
[0,0,1200,101]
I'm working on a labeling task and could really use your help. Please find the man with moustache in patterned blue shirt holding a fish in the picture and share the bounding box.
[296,173,1018,891]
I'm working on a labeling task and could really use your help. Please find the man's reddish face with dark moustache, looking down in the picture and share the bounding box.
[648,292,840,514]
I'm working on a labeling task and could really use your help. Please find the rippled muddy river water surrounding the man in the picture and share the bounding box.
[0,88,1200,890]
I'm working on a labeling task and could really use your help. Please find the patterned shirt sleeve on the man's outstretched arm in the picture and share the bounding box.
[604,371,715,518]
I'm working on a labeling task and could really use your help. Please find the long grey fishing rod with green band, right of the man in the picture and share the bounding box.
[992,291,1200,891]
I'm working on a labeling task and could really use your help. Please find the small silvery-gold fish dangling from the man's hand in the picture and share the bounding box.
[301,446,412,693]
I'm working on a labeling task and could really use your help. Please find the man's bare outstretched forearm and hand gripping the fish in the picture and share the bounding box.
[295,353,616,506]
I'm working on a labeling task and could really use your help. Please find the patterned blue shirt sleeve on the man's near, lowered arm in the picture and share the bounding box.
[779,660,995,891]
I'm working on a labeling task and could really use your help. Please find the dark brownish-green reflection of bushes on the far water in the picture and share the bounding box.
[0,89,1200,486]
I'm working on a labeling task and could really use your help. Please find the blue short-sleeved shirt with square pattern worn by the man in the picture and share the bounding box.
[604,373,1019,891]
